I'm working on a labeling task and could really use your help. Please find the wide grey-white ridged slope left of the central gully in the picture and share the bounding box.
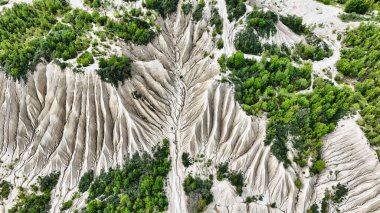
[0,61,171,210]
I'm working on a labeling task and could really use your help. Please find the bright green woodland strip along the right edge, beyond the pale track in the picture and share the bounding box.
[336,24,380,158]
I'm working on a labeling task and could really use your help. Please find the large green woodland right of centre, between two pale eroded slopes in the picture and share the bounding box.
[221,52,359,170]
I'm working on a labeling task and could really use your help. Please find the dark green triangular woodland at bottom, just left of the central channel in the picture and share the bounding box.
[75,139,170,213]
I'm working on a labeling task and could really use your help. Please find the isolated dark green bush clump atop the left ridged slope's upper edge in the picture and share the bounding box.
[96,55,131,86]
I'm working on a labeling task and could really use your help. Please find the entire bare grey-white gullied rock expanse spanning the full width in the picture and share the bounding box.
[0,1,380,213]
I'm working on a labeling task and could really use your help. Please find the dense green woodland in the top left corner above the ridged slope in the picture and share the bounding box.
[0,0,155,84]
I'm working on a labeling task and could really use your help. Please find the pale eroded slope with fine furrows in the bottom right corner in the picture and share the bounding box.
[315,116,380,212]
